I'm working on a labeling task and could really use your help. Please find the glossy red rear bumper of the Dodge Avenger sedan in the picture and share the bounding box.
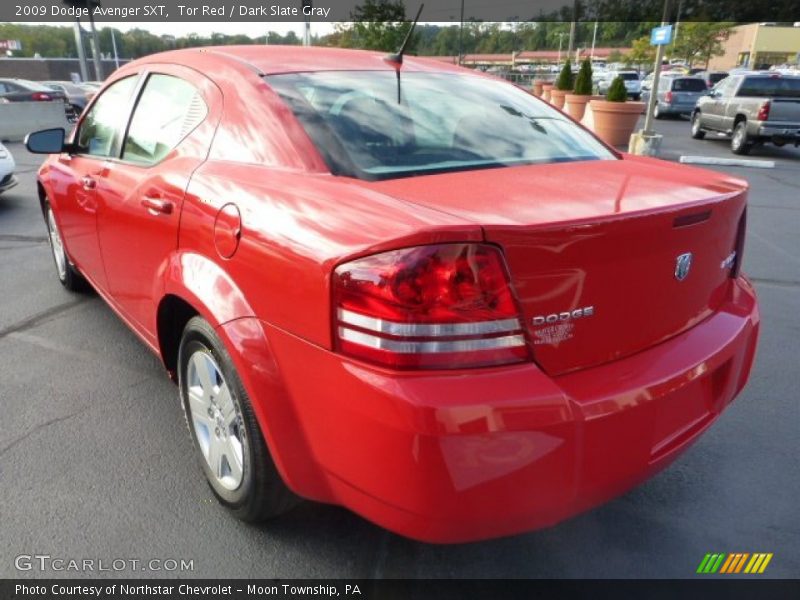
[242,279,759,542]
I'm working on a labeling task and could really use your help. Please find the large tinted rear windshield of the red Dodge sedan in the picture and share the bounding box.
[266,71,614,180]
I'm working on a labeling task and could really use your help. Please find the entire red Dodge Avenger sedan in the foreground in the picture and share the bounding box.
[28,46,759,542]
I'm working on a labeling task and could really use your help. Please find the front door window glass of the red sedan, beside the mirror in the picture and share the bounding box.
[75,75,137,157]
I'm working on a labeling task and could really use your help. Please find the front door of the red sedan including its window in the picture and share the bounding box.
[49,75,137,290]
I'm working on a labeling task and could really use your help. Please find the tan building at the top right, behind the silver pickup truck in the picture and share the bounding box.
[709,23,800,71]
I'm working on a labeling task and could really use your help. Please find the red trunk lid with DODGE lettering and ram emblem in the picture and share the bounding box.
[366,158,746,375]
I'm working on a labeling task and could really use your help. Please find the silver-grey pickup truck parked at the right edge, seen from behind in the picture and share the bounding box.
[692,73,800,154]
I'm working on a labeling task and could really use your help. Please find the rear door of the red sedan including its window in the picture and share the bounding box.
[98,65,222,341]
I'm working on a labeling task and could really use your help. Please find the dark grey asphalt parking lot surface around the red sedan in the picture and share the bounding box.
[0,115,800,578]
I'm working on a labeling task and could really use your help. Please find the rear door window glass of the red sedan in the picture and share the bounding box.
[122,74,208,164]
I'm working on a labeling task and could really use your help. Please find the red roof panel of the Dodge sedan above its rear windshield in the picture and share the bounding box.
[127,45,464,75]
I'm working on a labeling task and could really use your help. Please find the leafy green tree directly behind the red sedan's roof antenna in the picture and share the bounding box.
[336,0,414,52]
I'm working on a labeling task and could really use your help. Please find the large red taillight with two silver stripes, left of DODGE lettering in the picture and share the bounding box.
[333,244,529,369]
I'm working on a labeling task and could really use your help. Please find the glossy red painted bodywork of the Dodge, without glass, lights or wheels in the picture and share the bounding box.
[39,47,759,542]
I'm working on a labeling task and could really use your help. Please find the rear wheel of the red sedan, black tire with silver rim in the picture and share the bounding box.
[178,317,297,522]
